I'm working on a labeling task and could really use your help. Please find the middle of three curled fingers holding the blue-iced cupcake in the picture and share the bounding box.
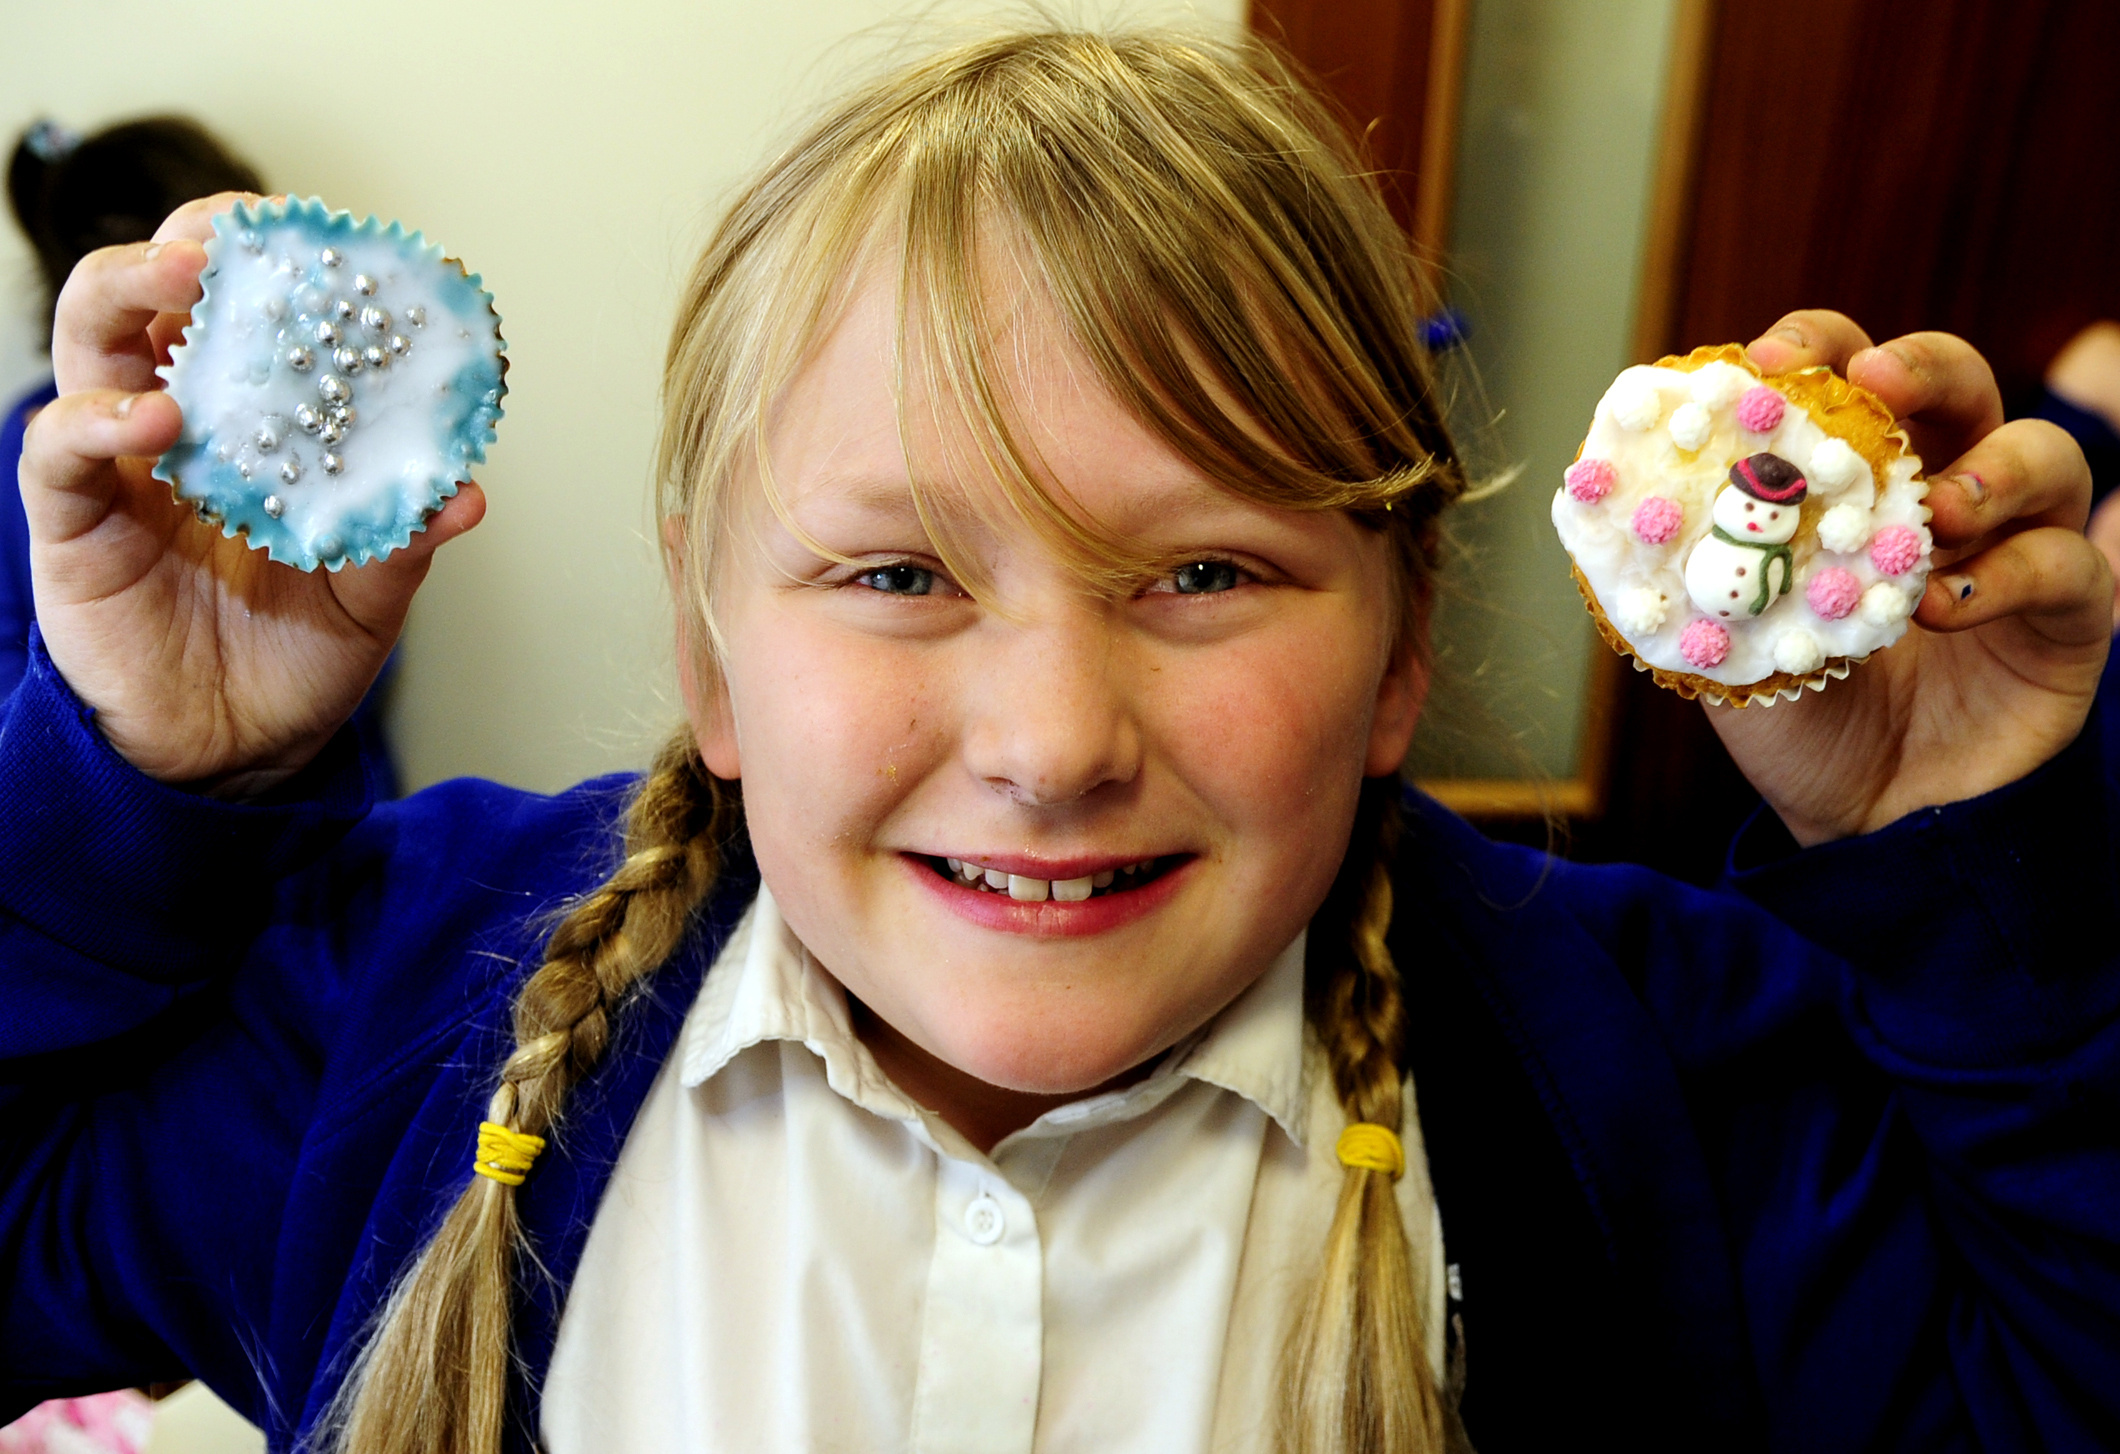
[51,237,206,394]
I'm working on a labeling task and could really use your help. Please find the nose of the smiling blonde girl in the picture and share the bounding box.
[962,602,1141,808]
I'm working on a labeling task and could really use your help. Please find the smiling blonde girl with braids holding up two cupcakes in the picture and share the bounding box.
[0,34,2120,1454]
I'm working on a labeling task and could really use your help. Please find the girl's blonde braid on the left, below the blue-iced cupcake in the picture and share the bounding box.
[322,731,742,1454]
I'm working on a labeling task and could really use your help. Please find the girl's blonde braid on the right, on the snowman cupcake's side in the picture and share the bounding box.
[1283,778,1444,1454]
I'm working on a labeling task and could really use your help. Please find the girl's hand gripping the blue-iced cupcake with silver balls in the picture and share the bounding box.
[21,195,485,797]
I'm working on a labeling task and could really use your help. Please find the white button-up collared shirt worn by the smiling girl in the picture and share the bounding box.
[541,890,1444,1454]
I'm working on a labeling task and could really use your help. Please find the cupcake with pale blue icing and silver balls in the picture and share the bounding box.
[155,197,507,570]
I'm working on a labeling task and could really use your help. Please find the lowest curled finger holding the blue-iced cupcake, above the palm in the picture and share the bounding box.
[21,388,184,543]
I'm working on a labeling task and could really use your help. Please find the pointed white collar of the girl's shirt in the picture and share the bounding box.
[678,884,1310,1145]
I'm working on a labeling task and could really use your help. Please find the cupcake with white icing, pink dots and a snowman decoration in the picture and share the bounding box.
[1554,343,1931,706]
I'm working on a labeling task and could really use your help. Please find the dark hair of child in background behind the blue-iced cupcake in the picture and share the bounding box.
[6,117,265,345]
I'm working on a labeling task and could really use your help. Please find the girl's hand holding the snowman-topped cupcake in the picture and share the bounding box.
[1709,312,2114,846]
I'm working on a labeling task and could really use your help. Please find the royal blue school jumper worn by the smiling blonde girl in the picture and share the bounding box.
[0,646,2120,1454]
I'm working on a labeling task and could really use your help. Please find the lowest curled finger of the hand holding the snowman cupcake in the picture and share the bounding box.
[1914,526,2114,646]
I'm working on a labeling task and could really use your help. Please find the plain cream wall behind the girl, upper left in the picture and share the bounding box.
[0,0,1244,791]
